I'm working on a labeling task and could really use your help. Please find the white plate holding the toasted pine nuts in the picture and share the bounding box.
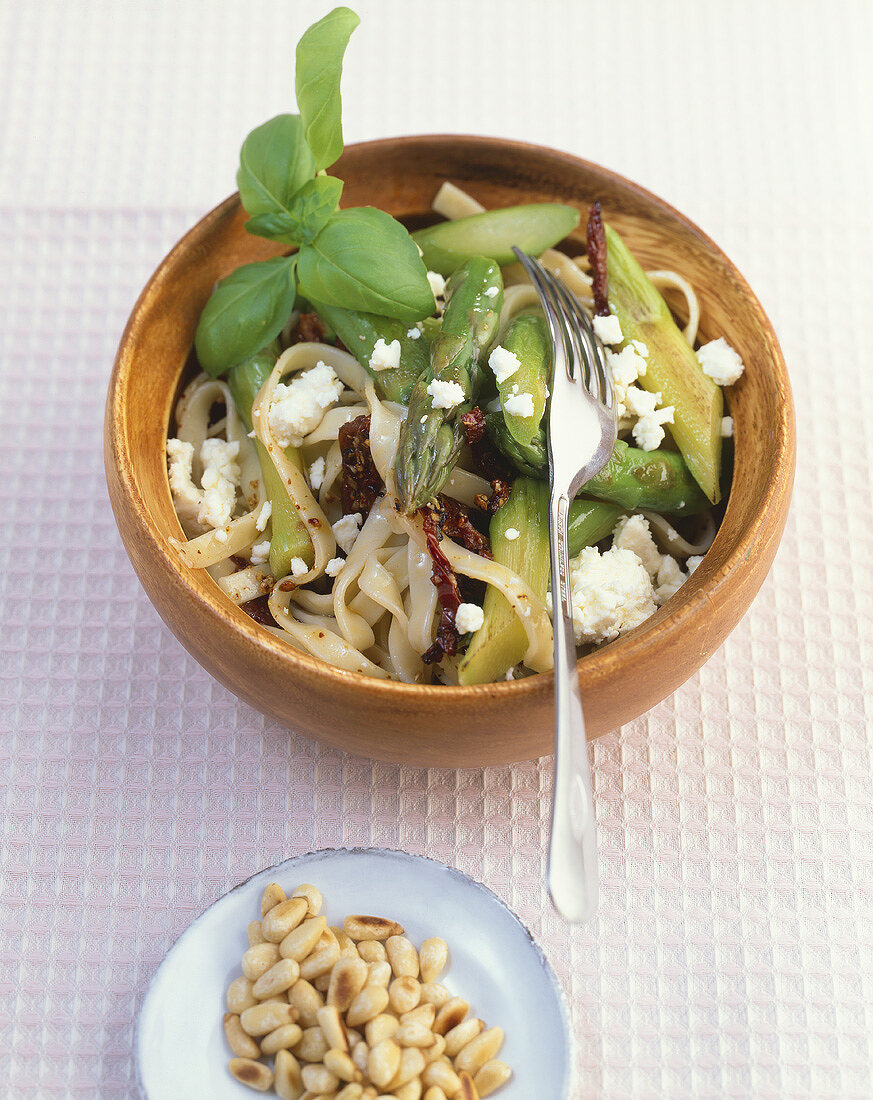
[136,848,572,1100]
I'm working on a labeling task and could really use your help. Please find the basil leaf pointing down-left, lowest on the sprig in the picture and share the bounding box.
[195,256,297,377]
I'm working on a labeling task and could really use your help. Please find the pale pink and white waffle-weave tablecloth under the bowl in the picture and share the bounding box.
[0,0,873,1100]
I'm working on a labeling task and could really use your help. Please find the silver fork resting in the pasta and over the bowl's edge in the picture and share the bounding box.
[512,249,617,922]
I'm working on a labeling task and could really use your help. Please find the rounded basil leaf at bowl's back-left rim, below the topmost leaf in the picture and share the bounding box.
[236,114,316,217]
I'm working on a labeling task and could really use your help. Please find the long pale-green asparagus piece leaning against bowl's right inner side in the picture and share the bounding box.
[605,226,722,504]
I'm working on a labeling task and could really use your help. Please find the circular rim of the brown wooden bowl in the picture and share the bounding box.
[106,133,795,702]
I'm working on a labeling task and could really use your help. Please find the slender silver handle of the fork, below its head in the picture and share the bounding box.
[549,488,597,922]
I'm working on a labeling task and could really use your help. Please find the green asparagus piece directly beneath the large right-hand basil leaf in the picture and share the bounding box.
[312,303,430,405]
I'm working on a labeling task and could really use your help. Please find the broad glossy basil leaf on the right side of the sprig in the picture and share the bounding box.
[297,207,437,321]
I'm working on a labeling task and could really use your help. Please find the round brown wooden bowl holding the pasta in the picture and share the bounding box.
[106,135,795,767]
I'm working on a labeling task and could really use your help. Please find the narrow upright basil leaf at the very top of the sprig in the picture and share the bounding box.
[295,8,361,169]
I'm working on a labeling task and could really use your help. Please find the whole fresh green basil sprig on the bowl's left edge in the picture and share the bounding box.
[195,8,435,376]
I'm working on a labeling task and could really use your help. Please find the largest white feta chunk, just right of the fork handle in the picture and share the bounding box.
[570,547,655,645]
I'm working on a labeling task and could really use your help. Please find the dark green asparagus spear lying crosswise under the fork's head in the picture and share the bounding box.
[485,413,709,516]
